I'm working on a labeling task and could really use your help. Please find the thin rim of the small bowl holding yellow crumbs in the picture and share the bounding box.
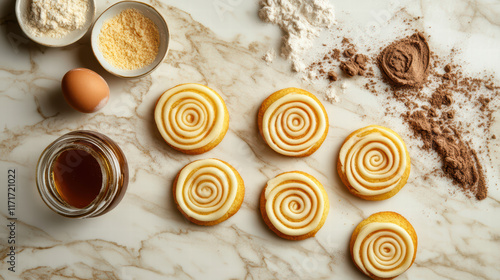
[90,0,170,79]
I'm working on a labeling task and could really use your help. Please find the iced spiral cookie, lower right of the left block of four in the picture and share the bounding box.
[261,172,329,238]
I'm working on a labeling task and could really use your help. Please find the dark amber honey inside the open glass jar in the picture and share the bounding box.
[53,149,103,208]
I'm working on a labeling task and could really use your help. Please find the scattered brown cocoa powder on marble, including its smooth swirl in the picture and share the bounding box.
[302,23,494,200]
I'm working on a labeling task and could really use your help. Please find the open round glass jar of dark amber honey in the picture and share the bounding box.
[36,130,129,218]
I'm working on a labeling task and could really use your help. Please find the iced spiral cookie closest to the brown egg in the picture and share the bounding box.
[155,84,229,153]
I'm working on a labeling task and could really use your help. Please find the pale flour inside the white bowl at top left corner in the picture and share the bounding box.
[25,0,89,38]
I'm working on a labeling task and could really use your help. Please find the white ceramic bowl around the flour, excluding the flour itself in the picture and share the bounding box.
[16,0,95,47]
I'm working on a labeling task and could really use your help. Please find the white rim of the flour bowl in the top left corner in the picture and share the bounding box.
[15,0,96,48]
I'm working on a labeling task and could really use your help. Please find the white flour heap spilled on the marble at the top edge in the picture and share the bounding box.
[259,0,335,72]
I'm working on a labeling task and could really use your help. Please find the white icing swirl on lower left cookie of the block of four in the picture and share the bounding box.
[175,159,238,222]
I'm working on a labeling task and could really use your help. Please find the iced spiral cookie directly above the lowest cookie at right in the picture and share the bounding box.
[339,125,410,198]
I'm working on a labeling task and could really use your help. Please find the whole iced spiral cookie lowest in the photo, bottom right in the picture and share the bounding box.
[349,212,418,280]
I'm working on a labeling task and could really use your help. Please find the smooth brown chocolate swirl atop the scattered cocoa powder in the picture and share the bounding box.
[379,33,430,86]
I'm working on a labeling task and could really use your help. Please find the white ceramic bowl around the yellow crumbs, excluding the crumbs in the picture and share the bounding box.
[91,1,170,78]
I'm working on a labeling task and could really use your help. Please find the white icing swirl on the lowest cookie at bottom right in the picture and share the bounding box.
[353,223,415,278]
